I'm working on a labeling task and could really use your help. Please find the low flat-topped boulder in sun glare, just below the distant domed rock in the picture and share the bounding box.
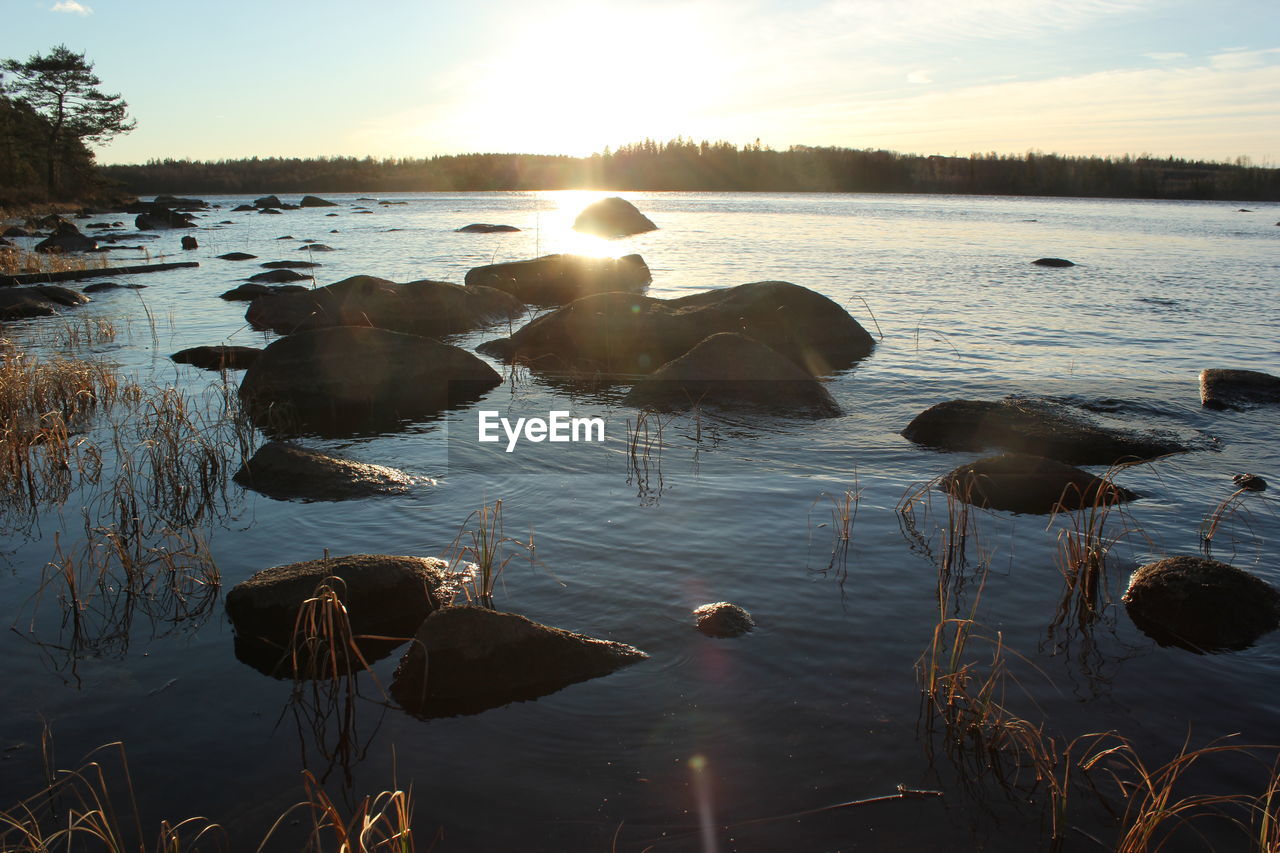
[463,255,653,305]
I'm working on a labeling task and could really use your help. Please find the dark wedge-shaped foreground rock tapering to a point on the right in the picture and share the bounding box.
[390,607,649,717]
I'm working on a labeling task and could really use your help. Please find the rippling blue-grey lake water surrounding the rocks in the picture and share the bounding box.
[0,193,1280,850]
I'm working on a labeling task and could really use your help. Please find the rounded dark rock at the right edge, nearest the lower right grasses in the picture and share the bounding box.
[1121,556,1280,652]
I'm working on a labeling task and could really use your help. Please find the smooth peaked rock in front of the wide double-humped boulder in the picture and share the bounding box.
[625,332,842,418]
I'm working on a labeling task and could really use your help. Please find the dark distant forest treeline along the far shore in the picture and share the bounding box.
[100,138,1280,201]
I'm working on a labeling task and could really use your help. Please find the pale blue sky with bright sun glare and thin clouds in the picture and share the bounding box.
[0,0,1280,167]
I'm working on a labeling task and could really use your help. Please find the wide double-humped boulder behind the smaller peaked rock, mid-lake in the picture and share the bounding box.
[480,282,876,375]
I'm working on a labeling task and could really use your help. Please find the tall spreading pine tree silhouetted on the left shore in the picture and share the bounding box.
[0,45,134,196]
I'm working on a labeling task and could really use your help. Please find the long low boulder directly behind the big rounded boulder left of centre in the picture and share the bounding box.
[244,275,525,336]
